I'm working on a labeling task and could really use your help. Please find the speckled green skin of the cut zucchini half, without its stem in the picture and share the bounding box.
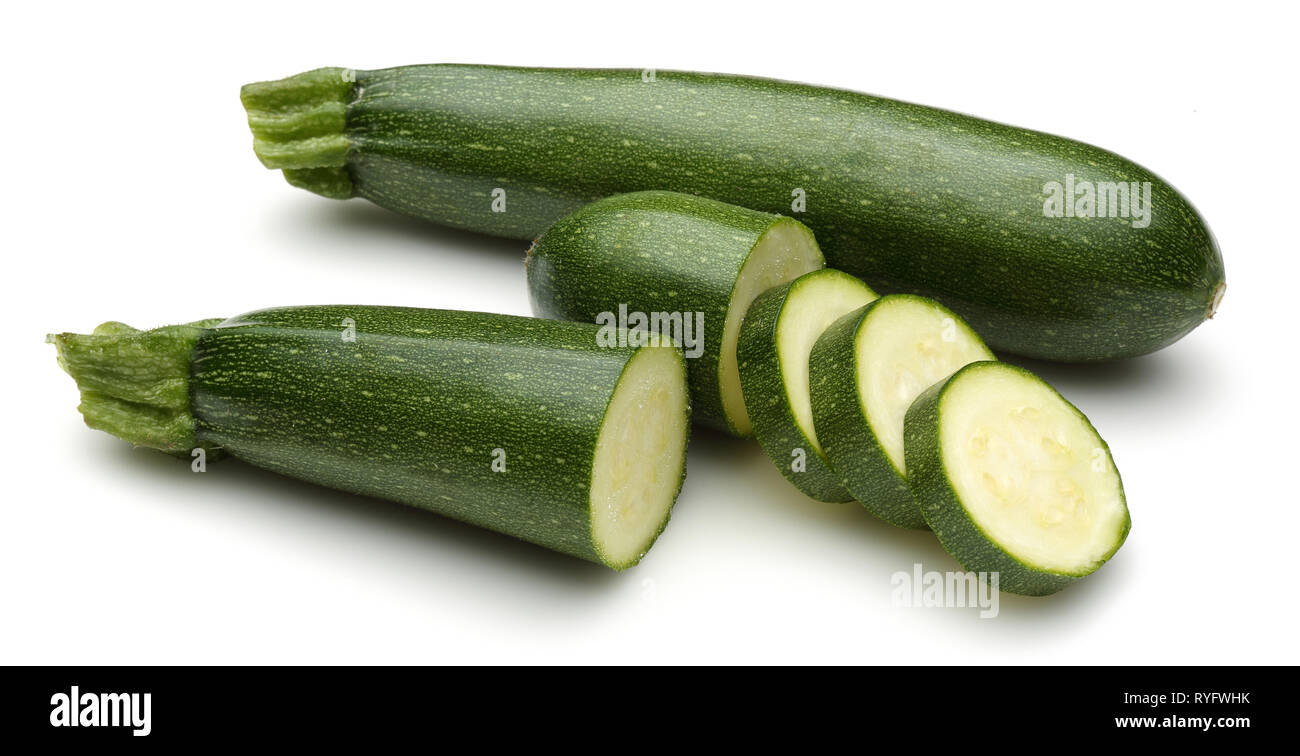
[190,307,686,569]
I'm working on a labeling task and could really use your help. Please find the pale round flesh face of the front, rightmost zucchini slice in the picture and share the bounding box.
[940,368,1127,574]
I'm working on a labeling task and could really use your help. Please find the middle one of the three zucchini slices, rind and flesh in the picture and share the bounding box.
[809,294,995,527]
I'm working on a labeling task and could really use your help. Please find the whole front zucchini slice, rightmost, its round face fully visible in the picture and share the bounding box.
[904,361,1130,596]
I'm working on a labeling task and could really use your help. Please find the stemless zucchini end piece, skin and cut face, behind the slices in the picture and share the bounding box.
[527,191,824,436]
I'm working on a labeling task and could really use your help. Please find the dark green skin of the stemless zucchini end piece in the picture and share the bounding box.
[527,191,816,435]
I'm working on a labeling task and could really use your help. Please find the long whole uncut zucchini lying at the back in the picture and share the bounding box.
[242,65,1223,361]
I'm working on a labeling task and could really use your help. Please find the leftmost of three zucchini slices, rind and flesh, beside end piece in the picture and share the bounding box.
[737,268,876,501]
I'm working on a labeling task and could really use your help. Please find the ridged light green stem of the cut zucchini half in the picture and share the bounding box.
[47,320,220,457]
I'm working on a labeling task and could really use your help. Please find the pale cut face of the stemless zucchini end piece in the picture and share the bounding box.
[718,221,826,435]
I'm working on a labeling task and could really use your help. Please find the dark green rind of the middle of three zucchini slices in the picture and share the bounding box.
[809,299,928,530]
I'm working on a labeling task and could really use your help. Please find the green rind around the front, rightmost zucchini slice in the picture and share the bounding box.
[904,361,1131,596]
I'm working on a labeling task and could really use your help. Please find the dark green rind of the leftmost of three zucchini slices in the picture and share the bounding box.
[736,278,853,501]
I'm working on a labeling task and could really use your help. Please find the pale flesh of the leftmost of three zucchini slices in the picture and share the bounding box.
[776,270,876,453]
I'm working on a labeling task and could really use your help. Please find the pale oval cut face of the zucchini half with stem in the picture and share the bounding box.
[590,347,689,566]
